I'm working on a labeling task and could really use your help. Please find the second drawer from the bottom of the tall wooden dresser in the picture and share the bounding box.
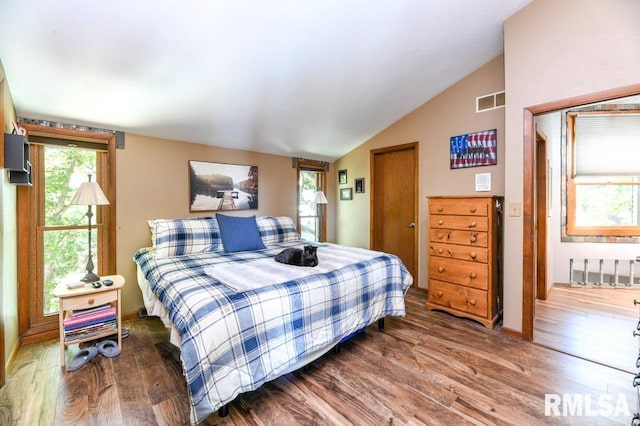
[429,257,489,290]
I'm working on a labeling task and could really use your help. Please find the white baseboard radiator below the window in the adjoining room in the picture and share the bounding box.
[569,258,640,287]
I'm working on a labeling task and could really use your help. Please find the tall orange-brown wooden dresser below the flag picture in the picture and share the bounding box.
[427,196,502,328]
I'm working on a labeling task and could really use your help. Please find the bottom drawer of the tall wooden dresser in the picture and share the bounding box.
[429,280,488,317]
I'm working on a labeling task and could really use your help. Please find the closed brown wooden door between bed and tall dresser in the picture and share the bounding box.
[370,142,418,286]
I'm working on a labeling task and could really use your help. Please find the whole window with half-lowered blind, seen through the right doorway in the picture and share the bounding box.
[567,110,640,236]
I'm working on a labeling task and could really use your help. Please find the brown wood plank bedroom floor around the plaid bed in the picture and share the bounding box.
[0,290,637,425]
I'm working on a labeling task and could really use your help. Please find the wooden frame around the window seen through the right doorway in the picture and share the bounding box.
[566,110,640,236]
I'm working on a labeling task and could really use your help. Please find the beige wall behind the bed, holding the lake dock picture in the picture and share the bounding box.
[116,134,334,313]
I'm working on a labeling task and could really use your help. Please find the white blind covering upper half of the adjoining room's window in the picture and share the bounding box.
[574,113,640,176]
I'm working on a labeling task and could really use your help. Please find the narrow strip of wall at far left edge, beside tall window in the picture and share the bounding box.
[0,63,18,365]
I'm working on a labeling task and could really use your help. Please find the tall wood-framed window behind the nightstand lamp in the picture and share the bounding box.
[18,123,115,342]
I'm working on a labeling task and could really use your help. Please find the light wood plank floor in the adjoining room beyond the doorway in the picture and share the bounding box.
[533,285,640,372]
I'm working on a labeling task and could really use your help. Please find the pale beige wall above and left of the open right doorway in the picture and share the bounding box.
[504,0,640,331]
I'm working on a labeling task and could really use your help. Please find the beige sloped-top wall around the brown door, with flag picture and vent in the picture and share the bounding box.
[335,56,509,287]
